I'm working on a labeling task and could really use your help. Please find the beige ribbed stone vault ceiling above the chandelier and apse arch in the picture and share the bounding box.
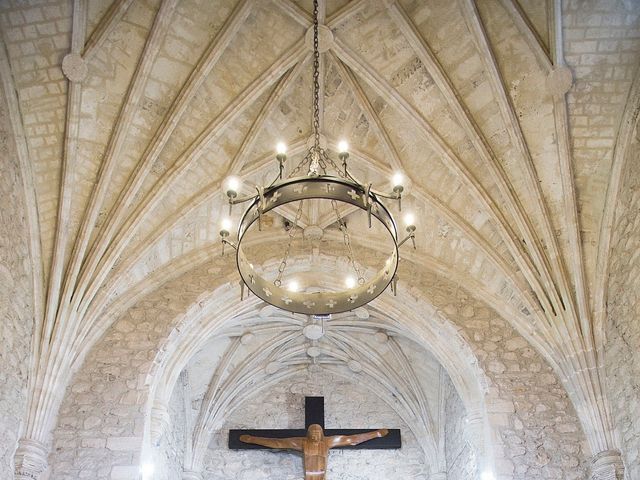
[0,0,640,472]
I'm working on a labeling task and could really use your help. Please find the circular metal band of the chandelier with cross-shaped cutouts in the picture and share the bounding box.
[235,175,404,315]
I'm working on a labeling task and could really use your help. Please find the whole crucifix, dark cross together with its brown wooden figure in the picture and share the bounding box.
[229,397,402,480]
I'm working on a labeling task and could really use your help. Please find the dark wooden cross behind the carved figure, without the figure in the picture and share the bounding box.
[229,397,402,450]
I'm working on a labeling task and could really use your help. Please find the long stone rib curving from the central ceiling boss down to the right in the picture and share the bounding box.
[334,40,555,318]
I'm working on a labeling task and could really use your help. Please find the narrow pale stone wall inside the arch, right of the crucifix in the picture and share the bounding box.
[445,382,479,480]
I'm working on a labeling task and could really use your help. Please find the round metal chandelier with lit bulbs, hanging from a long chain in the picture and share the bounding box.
[220,0,416,315]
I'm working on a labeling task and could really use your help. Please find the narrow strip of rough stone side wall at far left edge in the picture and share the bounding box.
[0,67,34,480]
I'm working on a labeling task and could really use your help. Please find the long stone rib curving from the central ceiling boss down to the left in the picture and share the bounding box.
[73,40,305,318]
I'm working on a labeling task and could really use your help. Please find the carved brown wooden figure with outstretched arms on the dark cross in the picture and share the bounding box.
[240,424,389,480]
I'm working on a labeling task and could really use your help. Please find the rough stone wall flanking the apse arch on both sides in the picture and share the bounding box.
[51,248,585,480]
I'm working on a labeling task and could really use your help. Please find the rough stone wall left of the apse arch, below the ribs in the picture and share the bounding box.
[49,256,226,480]
